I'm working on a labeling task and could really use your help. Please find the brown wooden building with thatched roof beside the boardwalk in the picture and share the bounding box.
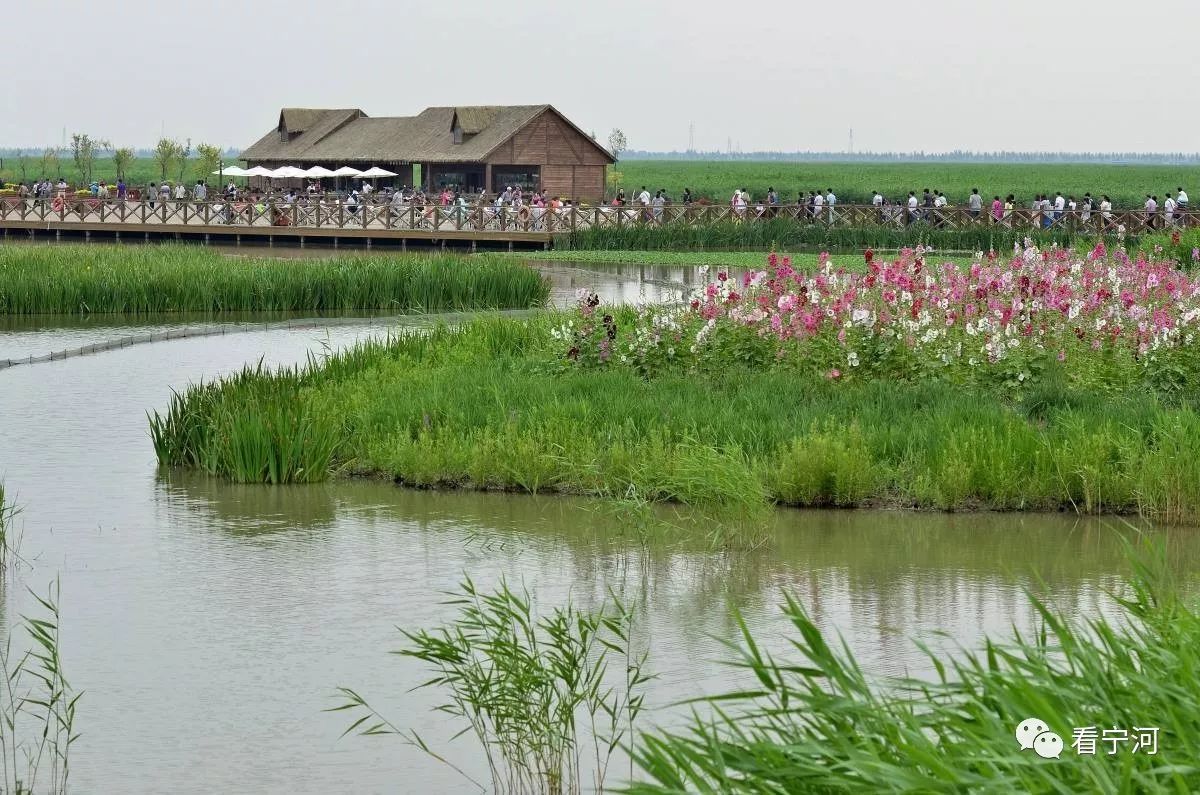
[241,104,614,202]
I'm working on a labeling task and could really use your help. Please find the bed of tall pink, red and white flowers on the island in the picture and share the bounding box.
[557,244,1200,391]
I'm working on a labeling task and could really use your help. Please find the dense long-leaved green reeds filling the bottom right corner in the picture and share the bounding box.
[628,549,1200,795]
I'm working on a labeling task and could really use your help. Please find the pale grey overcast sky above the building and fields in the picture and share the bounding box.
[9,0,1200,151]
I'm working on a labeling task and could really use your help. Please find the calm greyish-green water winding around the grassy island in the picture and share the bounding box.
[0,260,1200,793]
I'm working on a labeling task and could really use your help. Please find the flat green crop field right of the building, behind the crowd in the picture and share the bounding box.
[610,160,1200,209]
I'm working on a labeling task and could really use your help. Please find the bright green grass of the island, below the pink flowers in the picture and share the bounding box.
[151,311,1200,522]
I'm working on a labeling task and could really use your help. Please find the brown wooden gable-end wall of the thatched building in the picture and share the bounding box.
[488,110,608,202]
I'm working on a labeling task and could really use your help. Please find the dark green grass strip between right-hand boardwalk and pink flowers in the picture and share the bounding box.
[557,219,1136,251]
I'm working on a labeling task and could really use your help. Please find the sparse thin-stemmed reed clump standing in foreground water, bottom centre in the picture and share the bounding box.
[332,578,649,795]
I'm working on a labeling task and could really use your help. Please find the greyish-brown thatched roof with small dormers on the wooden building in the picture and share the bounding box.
[241,104,612,165]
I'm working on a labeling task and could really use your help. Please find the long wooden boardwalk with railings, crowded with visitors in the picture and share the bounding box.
[0,197,1185,249]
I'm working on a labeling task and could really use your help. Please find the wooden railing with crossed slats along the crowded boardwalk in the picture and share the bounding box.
[0,197,1200,235]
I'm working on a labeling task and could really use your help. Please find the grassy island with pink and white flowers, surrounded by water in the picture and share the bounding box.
[152,246,1200,522]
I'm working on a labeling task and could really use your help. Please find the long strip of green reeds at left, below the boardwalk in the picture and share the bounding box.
[0,245,550,315]
